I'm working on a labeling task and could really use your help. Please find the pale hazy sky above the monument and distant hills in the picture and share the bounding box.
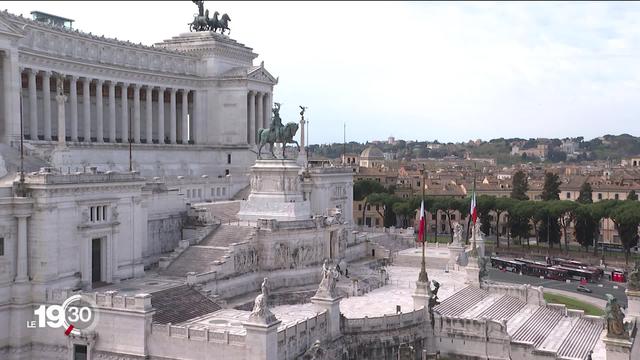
[0,0,640,143]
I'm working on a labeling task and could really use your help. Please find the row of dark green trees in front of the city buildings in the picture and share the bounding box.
[354,171,640,262]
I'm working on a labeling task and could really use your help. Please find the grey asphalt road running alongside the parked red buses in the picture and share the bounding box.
[488,268,627,308]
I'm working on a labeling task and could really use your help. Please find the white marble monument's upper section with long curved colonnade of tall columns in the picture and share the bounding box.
[0,12,277,181]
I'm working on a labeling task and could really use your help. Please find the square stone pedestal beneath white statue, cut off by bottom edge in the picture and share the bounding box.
[243,320,282,360]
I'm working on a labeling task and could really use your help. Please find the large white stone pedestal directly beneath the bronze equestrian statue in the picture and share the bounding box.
[238,159,311,221]
